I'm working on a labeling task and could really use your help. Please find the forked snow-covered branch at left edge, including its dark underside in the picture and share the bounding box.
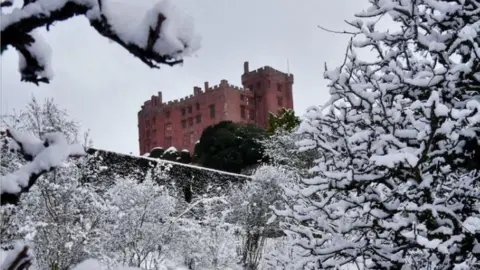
[0,129,85,205]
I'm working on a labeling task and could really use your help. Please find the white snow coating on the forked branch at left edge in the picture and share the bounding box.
[0,130,85,194]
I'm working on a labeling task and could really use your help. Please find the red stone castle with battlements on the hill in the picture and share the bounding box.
[138,62,293,155]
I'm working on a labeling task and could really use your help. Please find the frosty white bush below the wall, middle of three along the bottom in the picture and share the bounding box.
[103,176,176,269]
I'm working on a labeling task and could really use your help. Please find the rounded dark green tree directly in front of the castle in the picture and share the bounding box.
[194,121,266,173]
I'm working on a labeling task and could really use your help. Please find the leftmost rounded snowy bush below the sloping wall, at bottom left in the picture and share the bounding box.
[8,159,111,269]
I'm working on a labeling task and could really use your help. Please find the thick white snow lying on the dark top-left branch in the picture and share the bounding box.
[0,0,201,79]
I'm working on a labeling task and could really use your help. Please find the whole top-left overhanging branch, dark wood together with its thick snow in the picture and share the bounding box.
[1,0,199,85]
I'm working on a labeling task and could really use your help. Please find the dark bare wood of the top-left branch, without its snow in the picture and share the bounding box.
[1,0,188,85]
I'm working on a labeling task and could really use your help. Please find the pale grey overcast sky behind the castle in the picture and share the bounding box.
[1,0,367,154]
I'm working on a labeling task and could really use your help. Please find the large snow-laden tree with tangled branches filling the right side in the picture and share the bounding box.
[272,0,480,269]
